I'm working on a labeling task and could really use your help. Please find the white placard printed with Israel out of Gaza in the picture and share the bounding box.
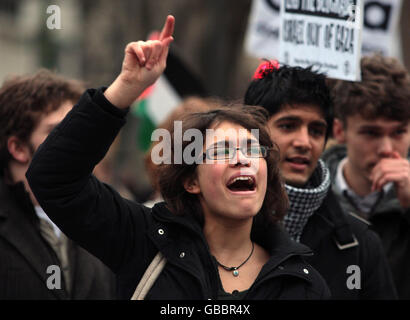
[279,0,363,81]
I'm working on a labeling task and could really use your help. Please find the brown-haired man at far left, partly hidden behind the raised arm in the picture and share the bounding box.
[0,70,116,300]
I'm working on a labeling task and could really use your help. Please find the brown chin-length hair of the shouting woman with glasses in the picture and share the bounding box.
[158,105,288,223]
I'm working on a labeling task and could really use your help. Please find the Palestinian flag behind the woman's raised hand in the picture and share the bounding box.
[131,47,207,152]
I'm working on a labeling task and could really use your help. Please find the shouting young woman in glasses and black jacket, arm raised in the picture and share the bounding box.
[27,16,329,300]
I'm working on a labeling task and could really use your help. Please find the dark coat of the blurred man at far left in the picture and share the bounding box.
[0,180,116,300]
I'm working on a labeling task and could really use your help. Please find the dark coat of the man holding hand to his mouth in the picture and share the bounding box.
[323,145,410,299]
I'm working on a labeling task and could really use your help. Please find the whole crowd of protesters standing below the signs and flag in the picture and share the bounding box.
[0,16,410,300]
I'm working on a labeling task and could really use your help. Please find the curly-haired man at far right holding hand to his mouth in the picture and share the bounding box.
[323,55,410,299]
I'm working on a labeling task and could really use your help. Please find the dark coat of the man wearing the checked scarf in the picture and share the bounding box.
[301,191,397,300]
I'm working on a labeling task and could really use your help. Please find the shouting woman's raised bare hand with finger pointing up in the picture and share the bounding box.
[104,16,175,108]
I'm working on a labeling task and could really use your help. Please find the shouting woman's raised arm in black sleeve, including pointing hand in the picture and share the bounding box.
[26,16,175,271]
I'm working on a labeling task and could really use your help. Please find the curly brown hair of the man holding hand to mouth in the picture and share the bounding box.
[328,54,410,126]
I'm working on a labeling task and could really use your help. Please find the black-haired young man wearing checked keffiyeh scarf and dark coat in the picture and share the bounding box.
[245,61,397,299]
